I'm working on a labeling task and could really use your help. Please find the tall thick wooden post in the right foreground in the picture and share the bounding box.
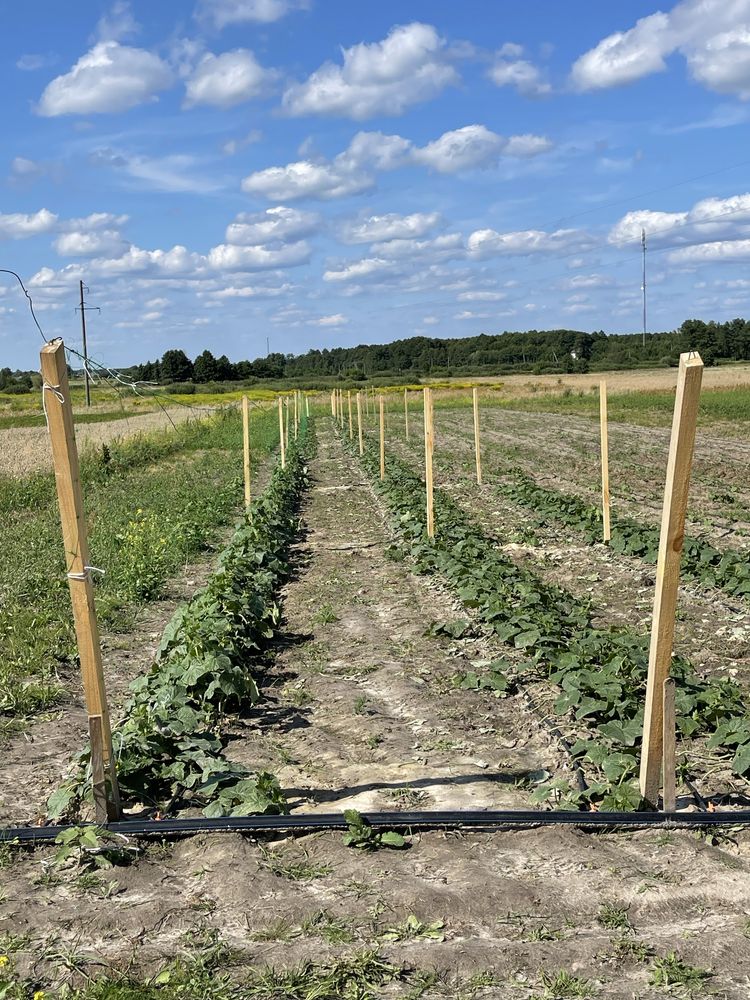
[640,354,703,805]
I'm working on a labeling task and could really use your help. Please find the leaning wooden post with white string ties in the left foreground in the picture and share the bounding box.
[40,340,120,818]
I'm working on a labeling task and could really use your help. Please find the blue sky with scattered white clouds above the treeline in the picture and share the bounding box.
[0,0,750,368]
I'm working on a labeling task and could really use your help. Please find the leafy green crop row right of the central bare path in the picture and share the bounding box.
[352,434,750,810]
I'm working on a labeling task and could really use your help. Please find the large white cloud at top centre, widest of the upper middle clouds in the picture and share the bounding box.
[283,22,458,121]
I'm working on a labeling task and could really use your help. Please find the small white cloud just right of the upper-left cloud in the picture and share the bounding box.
[185,49,276,108]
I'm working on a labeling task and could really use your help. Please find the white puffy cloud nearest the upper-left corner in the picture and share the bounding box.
[37,41,172,118]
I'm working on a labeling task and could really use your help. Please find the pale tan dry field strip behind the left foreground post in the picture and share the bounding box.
[0,406,196,476]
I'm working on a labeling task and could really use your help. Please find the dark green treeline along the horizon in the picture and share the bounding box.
[117,319,750,384]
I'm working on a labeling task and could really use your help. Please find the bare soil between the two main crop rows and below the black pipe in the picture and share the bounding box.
[0,427,750,1000]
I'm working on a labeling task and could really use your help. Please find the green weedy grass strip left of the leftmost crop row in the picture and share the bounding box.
[0,411,279,720]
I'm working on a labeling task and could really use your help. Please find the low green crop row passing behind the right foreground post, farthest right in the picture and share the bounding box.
[497,470,750,596]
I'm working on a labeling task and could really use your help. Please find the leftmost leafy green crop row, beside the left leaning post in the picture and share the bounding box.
[48,420,311,817]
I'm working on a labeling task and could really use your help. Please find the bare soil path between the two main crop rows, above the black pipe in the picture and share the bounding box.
[229,427,567,812]
